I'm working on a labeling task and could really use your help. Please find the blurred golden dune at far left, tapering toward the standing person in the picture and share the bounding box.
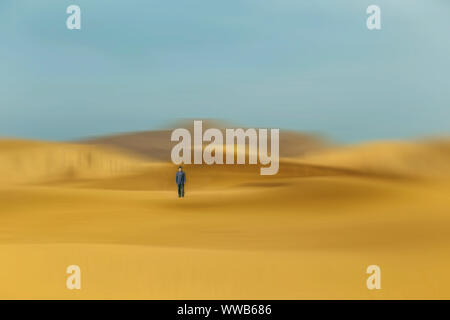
[0,140,144,184]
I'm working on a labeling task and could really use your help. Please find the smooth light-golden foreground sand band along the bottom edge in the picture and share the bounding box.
[0,244,450,299]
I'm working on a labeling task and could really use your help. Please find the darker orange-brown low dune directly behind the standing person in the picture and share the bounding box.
[49,159,363,191]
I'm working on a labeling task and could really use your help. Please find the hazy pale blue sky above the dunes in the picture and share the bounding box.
[0,0,450,143]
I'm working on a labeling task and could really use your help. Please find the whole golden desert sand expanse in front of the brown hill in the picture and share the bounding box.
[0,139,450,299]
